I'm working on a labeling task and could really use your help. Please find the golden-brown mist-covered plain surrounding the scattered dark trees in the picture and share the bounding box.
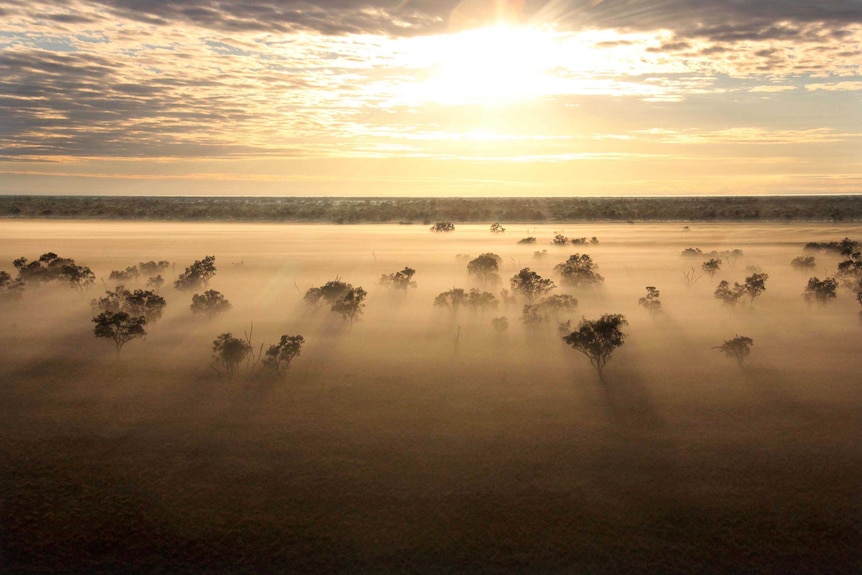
[0,220,862,573]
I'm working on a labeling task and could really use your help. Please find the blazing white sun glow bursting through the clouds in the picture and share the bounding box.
[400,24,560,106]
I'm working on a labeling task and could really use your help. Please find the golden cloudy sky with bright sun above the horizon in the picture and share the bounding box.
[0,0,862,197]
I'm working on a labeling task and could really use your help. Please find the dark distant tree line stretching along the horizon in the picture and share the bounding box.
[0,196,862,224]
